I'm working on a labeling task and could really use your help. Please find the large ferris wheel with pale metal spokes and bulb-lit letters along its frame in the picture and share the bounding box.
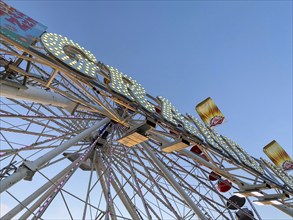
[0,2,293,220]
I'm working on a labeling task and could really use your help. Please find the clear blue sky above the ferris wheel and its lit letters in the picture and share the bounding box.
[6,1,293,219]
